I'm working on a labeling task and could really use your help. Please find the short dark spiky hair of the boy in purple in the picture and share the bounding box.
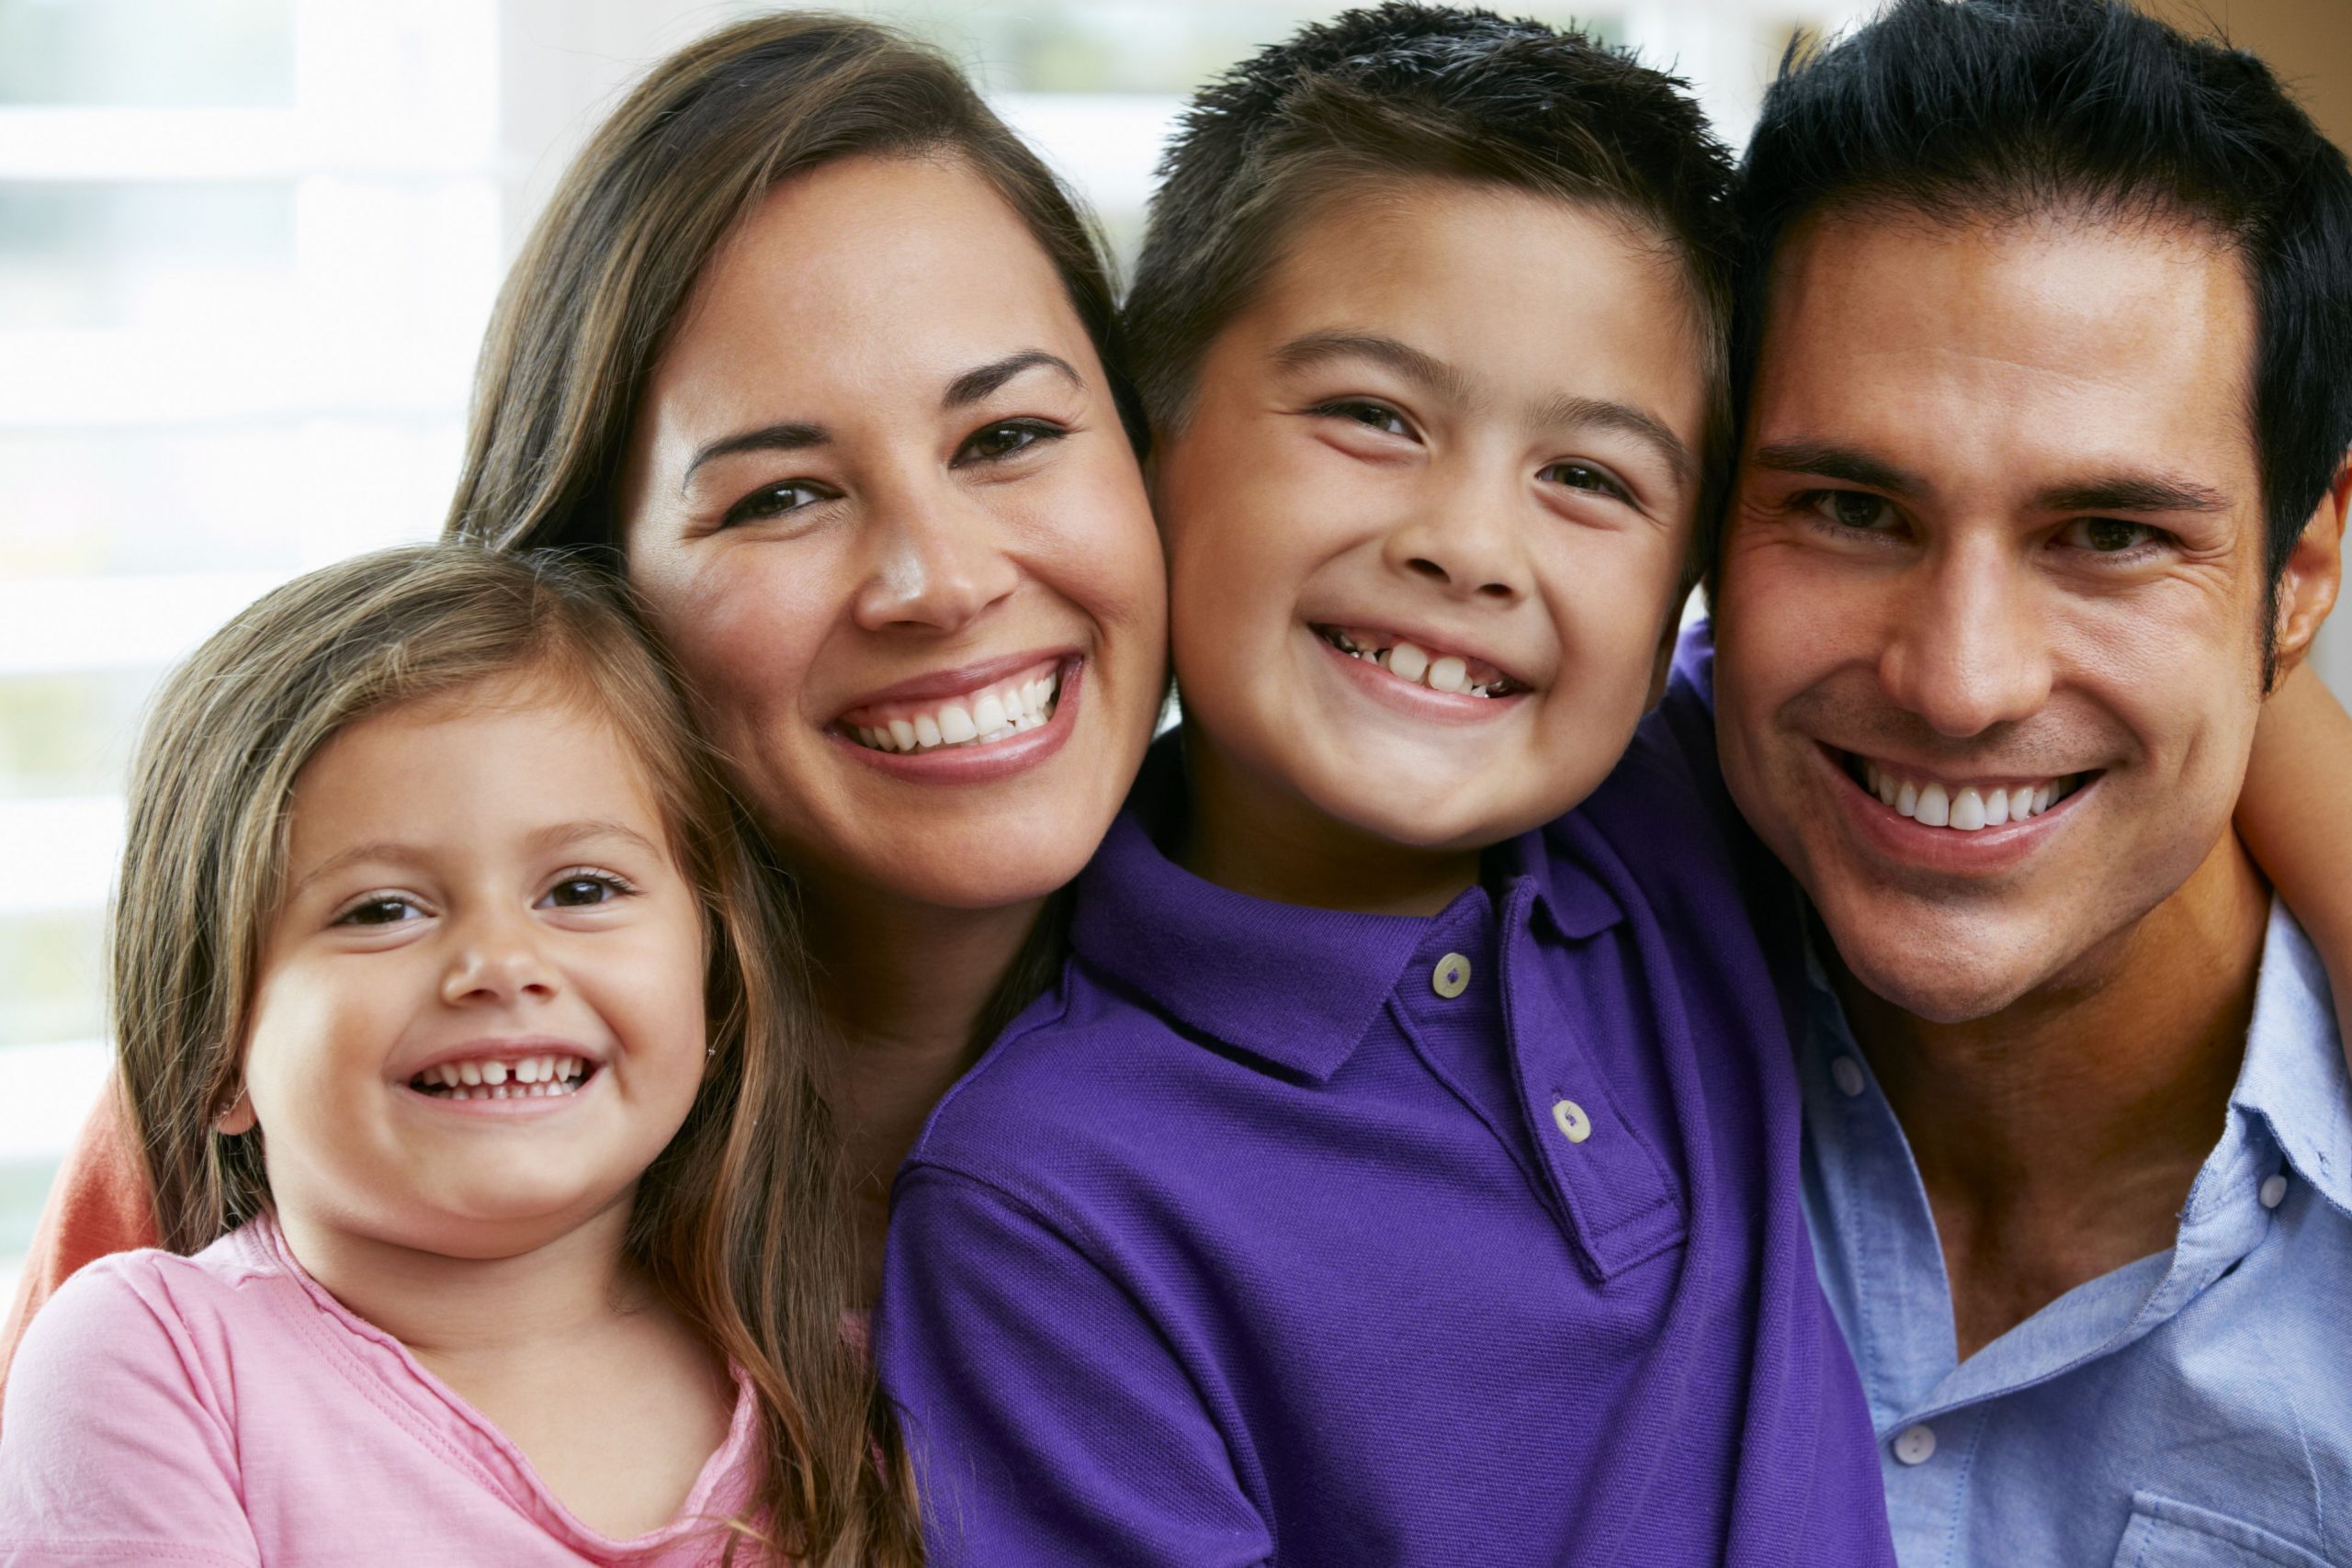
[1126,3,1734,540]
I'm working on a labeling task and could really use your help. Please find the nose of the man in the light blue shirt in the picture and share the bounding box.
[1879,538,2051,739]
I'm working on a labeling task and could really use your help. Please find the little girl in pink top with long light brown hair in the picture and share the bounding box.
[0,546,920,1565]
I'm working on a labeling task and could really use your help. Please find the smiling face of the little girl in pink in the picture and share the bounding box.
[228,682,706,1258]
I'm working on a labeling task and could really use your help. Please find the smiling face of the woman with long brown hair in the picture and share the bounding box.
[623,157,1164,908]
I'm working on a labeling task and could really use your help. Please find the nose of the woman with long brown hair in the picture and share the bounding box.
[852,475,1021,632]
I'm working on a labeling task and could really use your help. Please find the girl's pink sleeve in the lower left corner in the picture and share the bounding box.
[0,1256,261,1568]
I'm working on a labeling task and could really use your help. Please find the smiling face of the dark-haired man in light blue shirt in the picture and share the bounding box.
[1717,216,2314,1022]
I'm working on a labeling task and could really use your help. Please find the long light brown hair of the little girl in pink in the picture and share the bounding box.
[108,546,922,1565]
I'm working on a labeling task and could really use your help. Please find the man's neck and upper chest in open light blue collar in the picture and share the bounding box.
[1832,835,2269,1359]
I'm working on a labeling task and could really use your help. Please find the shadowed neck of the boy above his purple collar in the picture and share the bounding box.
[1179,731,1479,915]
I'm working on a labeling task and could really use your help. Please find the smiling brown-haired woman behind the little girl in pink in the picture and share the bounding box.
[0,14,1164,1371]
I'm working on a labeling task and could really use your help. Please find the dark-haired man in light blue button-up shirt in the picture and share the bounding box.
[1714,0,2352,1568]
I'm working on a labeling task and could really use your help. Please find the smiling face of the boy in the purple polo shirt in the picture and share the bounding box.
[1155,181,1708,893]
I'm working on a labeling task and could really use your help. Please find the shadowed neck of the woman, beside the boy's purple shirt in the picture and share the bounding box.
[802,886,1046,1304]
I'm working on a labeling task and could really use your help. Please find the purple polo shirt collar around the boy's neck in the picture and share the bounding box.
[1070,731,1621,1081]
